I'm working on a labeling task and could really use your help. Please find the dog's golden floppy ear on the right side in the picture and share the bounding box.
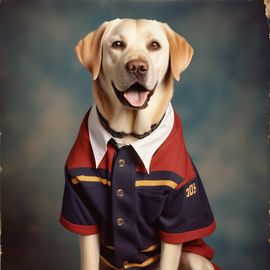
[163,24,194,81]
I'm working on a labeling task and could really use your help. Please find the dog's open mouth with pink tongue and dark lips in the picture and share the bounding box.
[112,82,157,110]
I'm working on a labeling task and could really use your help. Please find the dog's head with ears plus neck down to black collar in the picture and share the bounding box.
[76,19,193,137]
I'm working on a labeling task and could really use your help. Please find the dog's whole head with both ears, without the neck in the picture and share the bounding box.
[76,19,193,109]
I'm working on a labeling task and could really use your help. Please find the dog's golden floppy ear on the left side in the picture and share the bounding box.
[75,22,109,80]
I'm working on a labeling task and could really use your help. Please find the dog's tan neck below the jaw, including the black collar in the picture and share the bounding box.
[93,74,173,143]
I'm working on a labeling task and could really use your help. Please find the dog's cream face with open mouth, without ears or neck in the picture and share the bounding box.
[100,20,169,109]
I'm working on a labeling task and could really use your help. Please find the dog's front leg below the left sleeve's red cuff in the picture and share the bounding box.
[80,234,99,270]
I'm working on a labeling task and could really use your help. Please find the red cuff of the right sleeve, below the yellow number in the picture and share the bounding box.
[160,222,216,244]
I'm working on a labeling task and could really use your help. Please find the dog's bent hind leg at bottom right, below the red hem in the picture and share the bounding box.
[178,252,214,270]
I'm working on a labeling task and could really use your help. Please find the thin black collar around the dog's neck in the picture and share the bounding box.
[97,108,165,139]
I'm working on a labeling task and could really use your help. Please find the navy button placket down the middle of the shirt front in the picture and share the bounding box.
[112,147,137,262]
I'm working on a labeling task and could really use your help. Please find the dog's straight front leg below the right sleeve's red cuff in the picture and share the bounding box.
[160,242,182,270]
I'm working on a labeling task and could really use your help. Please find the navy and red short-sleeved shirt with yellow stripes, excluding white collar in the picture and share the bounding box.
[60,104,218,270]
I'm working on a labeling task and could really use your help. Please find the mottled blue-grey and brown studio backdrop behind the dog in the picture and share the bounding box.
[0,0,270,270]
